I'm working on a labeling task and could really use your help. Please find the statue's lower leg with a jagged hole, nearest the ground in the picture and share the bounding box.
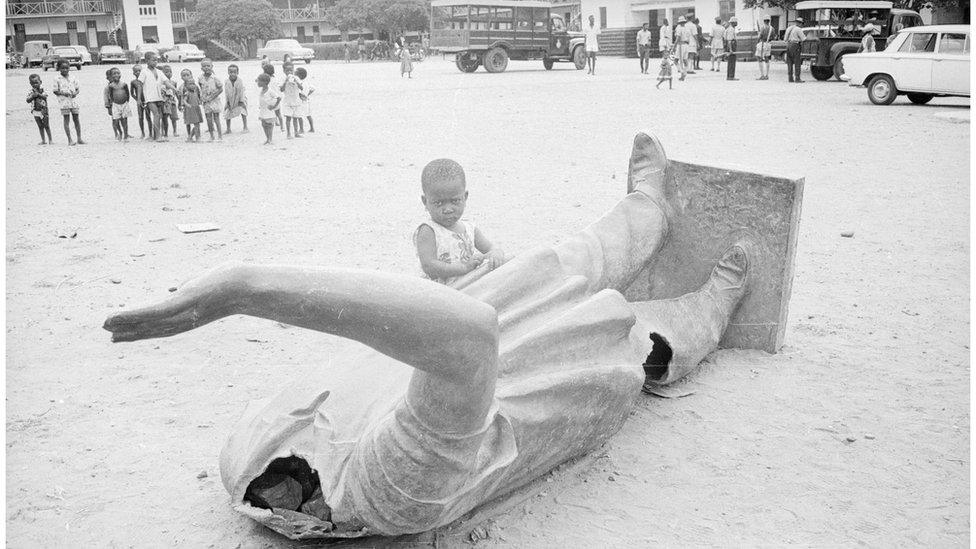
[631,240,757,389]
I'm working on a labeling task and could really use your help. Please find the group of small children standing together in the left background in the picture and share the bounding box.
[27,52,315,145]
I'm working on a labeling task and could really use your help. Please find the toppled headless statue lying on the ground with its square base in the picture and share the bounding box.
[105,134,802,539]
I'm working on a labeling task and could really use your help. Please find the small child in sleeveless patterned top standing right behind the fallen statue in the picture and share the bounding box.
[413,158,505,285]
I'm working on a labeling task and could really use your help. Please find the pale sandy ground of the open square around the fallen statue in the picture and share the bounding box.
[6,59,970,548]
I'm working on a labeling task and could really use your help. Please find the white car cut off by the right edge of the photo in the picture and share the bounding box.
[841,25,971,105]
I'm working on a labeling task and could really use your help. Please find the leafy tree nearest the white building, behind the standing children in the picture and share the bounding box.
[190,0,281,52]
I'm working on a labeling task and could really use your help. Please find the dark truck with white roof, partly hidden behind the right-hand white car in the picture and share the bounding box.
[794,0,922,80]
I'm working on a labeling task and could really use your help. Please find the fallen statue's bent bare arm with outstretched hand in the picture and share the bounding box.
[104,263,498,432]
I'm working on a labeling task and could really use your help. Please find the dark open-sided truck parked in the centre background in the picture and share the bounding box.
[430,0,586,73]
